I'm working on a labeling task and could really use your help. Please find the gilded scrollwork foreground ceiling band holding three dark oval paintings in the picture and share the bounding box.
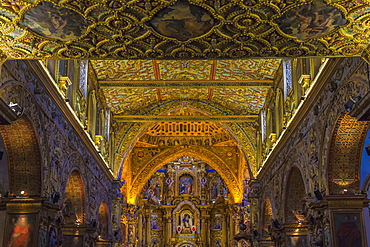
[0,0,370,60]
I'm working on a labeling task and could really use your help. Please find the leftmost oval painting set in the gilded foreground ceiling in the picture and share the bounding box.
[19,2,91,41]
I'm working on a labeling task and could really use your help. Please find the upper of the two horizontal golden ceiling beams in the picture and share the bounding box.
[99,80,273,88]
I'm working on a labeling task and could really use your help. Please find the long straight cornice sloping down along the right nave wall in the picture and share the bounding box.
[257,58,345,181]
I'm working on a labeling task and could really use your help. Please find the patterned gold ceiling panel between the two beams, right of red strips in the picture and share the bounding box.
[212,87,269,115]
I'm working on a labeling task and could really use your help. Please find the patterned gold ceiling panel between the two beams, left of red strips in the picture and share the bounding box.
[103,88,157,115]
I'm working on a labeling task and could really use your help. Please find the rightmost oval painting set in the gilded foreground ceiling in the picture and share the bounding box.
[275,0,347,40]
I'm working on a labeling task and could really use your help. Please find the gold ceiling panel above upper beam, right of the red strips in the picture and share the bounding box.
[215,59,281,80]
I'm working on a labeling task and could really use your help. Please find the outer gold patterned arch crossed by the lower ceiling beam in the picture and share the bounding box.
[114,99,258,177]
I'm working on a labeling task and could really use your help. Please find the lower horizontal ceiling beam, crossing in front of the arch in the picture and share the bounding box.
[114,115,258,122]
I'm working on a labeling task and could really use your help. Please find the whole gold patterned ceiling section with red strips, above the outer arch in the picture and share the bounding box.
[91,59,281,115]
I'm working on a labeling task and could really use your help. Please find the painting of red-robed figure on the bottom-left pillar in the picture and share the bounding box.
[4,214,38,247]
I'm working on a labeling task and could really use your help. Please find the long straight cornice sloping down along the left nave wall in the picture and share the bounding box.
[25,60,114,182]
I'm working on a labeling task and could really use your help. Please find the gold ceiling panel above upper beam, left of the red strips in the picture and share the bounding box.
[91,60,155,81]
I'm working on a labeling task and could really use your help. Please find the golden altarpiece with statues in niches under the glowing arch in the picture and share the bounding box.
[121,156,249,247]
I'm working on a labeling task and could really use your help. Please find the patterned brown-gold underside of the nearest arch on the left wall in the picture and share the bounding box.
[0,116,42,195]
